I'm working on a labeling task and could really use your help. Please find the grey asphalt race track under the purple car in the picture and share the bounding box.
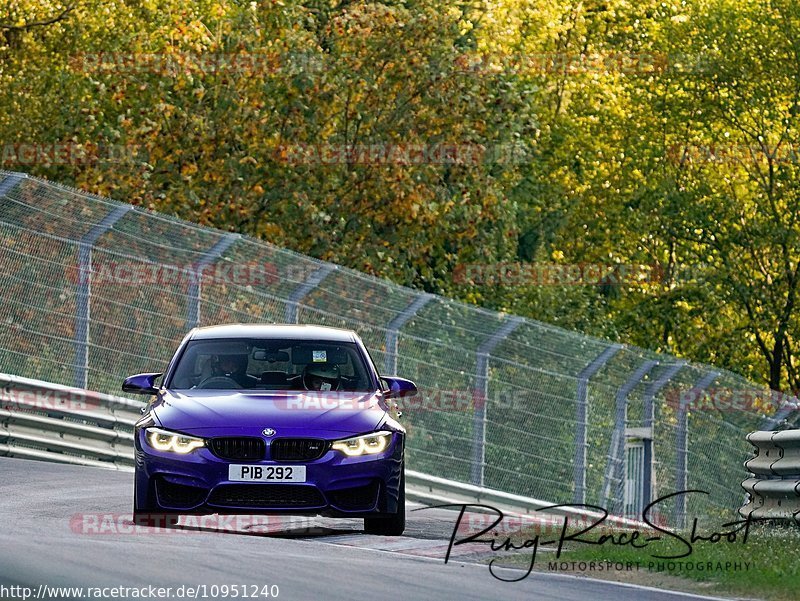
[0,457,732,601]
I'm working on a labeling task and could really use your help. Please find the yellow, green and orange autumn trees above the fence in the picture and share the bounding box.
[0,0,800,390]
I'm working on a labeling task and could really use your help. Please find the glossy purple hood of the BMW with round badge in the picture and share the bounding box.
[152,390,387,437]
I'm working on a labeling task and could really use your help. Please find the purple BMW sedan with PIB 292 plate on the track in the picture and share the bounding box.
[122,325,417,536]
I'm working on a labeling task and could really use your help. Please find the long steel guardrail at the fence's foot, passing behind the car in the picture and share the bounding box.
[0,374,656,527]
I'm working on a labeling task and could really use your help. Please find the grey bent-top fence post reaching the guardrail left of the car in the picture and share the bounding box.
[74,205,133,388]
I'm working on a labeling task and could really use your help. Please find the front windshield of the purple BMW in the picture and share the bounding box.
[167,338,374,392]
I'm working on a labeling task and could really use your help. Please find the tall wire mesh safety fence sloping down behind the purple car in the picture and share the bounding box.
[0,171,794,520]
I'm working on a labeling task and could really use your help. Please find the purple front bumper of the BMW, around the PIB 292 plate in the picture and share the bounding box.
[134,429,404,517]
